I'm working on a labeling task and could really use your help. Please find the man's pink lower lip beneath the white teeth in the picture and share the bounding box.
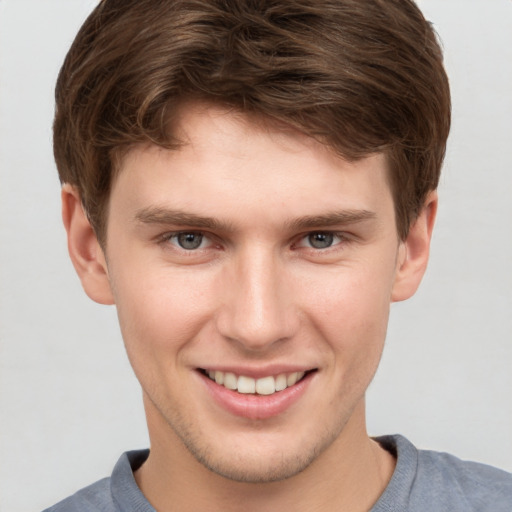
[198,372,314,420]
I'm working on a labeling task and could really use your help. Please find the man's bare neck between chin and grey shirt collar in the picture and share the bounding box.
[135,401,395,512]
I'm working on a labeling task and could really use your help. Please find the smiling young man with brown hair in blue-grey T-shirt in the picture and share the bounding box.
[44,0,512,511]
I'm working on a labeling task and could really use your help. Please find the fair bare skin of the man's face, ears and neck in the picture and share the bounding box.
[63,104,437,511]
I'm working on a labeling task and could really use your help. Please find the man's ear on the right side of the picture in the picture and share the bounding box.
[391,190,437,302]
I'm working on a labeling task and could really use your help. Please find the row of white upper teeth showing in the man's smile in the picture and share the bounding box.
[204,370,306,395]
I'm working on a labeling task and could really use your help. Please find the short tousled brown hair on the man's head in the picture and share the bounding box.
[54,0,450,242]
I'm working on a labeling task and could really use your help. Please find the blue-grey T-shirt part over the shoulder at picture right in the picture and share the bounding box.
[375,435,512,512]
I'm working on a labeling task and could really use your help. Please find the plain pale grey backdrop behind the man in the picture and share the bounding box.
[0,0,512,512]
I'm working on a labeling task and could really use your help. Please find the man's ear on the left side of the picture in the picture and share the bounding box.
[62,184,114,304]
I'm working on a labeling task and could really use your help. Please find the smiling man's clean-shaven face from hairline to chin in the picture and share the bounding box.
[97,105,408,481]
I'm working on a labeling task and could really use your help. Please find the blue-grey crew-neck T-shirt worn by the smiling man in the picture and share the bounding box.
[44,435,512,512]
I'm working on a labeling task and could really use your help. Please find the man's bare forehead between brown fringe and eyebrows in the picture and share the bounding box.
[111,103,392,231]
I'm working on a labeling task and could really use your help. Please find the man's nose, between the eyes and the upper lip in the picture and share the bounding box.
[217,248,298,352]
